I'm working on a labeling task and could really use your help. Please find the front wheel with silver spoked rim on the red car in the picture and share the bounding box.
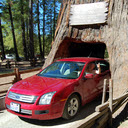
[62,94,80,119]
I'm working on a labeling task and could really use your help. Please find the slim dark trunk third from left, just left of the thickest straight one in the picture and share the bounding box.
[20,0,28,60]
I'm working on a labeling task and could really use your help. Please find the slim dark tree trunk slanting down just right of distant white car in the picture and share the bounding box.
[8,1,19,61]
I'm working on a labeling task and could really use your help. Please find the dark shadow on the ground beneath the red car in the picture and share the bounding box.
[19,97,101,126]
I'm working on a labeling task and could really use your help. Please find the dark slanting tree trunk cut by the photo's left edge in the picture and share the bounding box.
[0,18,5,60]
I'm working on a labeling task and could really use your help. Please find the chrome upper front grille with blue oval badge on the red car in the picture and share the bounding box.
[8,91,38,104]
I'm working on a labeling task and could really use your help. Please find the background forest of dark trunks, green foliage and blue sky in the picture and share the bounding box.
[0,0,61,61]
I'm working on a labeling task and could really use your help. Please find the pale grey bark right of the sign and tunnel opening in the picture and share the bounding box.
[103,0,128,96]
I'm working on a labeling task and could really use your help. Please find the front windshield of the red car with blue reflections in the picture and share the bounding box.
[37,61,85,79]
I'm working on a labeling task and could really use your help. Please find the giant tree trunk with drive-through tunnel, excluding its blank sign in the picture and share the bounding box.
[44,0,128,97]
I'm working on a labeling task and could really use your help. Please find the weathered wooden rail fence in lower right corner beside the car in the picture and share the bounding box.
[77,80,128,128]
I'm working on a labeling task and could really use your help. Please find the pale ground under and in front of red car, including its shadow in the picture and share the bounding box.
[0,97,101,128]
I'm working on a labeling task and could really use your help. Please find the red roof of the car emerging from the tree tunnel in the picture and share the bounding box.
[57,57,104,62]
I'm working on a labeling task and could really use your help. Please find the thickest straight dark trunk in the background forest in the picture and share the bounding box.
[29,0,34,60]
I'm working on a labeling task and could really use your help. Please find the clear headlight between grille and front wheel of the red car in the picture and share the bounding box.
[39,92,56,105]
